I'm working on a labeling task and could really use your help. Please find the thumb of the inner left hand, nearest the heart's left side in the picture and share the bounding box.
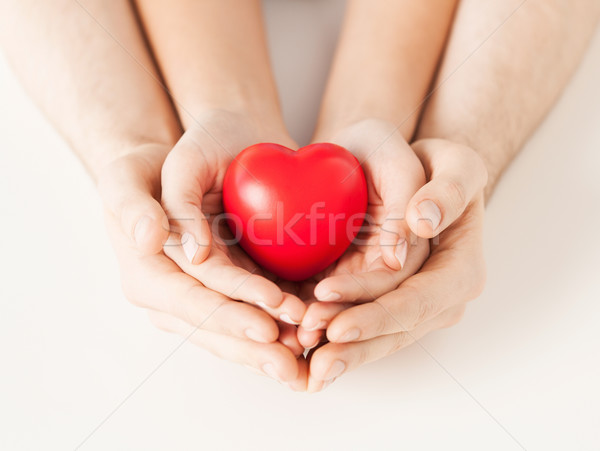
[162,131,218,264]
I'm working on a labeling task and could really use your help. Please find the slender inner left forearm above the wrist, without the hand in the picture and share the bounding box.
[137,0,283,134]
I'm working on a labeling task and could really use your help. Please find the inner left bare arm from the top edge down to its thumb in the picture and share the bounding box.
[137,0,295,264]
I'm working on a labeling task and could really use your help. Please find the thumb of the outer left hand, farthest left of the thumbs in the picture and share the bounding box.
[98,144,169,255]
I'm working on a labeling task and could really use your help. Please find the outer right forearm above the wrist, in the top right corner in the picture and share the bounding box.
[417,0,600,196]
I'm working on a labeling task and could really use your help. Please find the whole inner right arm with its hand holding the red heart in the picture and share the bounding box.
[298,0,456,354]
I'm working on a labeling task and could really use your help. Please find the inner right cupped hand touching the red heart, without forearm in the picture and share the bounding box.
[298,119,429,348]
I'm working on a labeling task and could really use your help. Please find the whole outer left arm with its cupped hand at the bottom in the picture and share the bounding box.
[0,0,306,389]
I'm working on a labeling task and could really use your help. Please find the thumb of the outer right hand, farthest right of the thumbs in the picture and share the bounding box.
[406,139,487,238]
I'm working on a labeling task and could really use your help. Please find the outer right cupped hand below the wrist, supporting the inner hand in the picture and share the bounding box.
[308,139,487,391]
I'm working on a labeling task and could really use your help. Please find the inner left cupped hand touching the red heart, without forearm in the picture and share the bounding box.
[162,111,306,324]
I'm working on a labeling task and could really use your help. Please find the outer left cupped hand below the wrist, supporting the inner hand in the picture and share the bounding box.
[98,144,307,389]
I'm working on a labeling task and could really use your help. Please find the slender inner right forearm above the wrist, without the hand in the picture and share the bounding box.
[316,0,456,140]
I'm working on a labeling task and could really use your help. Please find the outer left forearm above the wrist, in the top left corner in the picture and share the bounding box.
[0,0,179,176]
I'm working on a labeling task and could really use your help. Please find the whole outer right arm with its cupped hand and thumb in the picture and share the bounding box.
[305,0,600,391]
